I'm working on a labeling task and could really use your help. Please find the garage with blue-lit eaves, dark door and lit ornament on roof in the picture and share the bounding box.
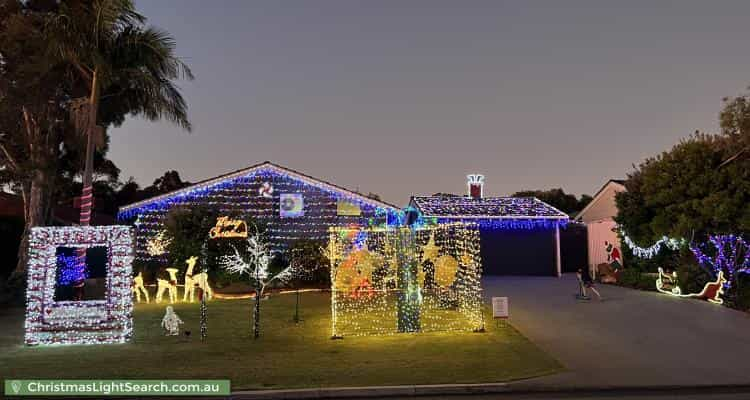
[410,175,569,276]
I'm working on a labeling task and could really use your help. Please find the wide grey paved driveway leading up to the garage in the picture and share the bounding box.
[483,274,750,387]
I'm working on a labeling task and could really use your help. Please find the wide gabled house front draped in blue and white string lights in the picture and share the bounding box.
[118,161,401,260]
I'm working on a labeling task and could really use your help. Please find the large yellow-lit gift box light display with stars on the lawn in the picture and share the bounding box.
[326,223,484,337]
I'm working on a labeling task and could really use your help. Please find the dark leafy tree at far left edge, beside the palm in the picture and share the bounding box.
[0,1,74,282]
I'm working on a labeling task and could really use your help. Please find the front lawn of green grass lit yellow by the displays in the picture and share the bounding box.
[0,293,562,390]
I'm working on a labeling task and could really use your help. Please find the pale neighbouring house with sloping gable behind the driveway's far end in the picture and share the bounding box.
[576,179,626,276]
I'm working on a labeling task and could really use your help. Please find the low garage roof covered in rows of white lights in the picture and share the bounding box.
[412,196,568,219]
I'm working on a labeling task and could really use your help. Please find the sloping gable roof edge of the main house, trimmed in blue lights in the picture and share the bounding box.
[119,161,398,215]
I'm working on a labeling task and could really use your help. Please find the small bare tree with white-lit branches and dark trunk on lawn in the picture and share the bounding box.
[220,228,292,339]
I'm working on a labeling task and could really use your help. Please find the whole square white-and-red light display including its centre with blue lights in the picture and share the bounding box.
[25,226,133,345]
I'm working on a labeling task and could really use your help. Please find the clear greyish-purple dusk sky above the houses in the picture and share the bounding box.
[109,0,750,205]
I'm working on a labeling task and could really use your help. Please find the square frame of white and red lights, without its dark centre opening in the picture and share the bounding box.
[24,226,133,345]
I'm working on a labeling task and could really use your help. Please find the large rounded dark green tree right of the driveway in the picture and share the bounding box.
[615,134,750,243]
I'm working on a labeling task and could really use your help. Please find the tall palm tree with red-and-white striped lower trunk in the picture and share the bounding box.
[47,0,193,225]
